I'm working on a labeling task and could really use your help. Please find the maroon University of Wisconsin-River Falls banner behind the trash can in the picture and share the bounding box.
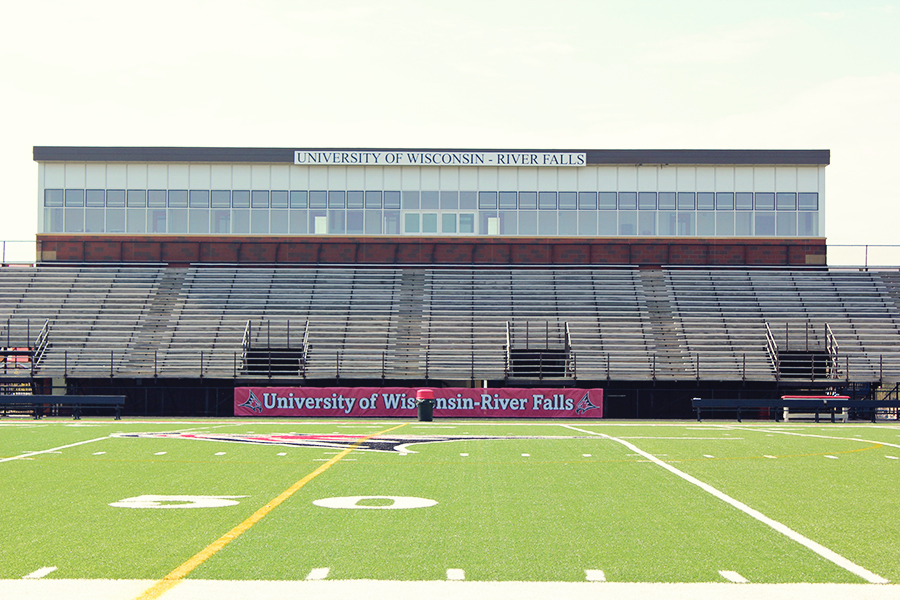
[234,387,603,419]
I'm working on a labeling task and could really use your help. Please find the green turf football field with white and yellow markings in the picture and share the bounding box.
[0,419,900,597]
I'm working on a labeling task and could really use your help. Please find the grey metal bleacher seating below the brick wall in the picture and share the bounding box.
[0,265,900,381]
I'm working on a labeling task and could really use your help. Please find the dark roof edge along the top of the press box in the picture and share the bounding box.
[34,146,831,165]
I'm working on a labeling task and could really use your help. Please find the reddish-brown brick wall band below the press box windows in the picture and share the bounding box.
[38,234,826,266]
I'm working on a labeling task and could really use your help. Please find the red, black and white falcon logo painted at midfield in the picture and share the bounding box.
[115,432,595,454]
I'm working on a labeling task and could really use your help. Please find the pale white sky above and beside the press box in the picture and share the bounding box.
[0,0,900,262]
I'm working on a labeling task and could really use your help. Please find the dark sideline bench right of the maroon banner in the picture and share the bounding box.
[691,396,900,423]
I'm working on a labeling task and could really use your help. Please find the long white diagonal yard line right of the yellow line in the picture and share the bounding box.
[563,425,889,583]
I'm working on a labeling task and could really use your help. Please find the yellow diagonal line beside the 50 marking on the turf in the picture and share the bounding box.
[135,423,406,600]
